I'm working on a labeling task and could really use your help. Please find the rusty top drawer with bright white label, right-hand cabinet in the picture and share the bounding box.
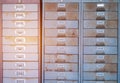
[83,3,118,11]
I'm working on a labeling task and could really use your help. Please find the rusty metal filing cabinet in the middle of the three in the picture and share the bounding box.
[43,0,79,83]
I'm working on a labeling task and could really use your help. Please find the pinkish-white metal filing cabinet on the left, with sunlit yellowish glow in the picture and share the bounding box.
[2,0,41,83]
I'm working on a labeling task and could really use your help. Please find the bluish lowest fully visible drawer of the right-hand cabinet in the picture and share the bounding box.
[84,72,117,81]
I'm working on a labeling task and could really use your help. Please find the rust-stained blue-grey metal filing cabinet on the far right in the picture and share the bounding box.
[83,0,118,83]
